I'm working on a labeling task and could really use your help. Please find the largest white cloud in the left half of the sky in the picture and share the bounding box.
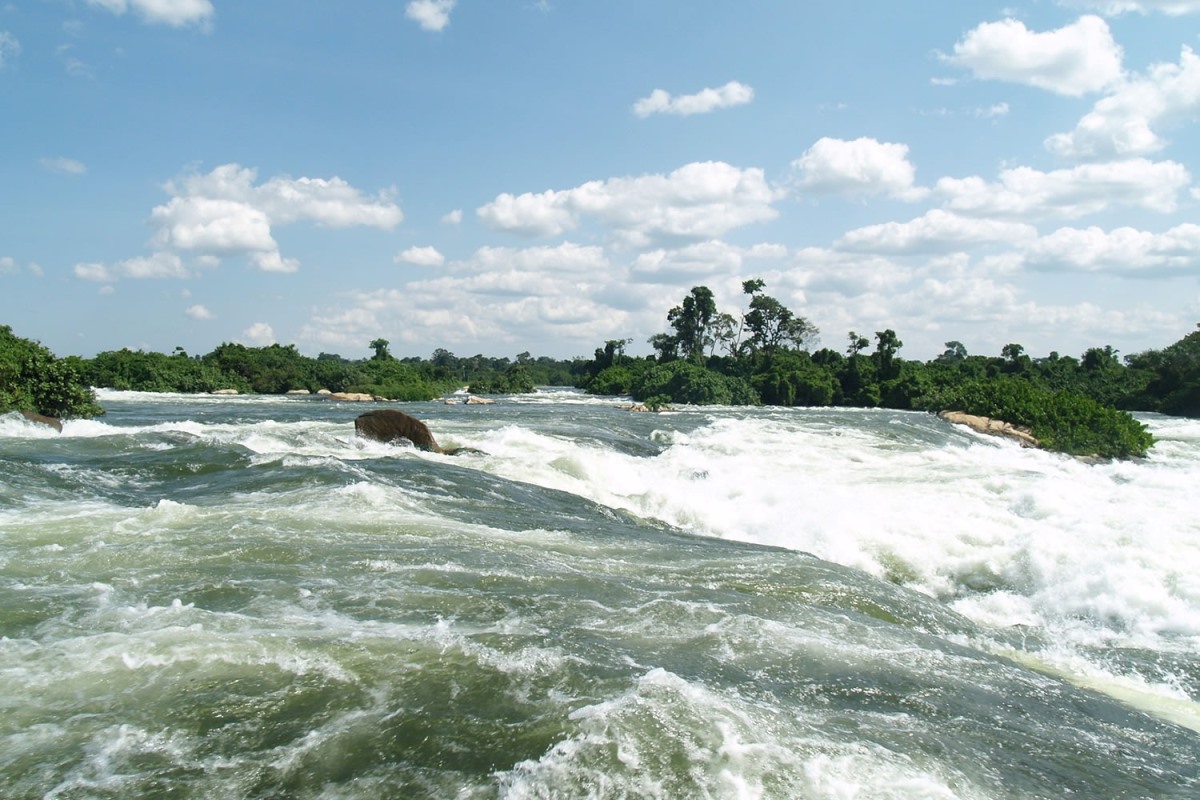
[141,164,404,272]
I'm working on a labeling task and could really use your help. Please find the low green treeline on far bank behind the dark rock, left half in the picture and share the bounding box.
[80,338,574,401]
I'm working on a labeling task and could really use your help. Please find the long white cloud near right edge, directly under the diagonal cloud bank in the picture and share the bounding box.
[934,158,1192,222]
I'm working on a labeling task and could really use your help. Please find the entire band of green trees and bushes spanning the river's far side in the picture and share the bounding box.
[0,278,1200,458]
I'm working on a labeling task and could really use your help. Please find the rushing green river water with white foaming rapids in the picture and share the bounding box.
[0,391,1200,800]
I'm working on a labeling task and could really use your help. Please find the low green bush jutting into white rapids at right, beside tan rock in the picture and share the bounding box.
[925,377,1154,458]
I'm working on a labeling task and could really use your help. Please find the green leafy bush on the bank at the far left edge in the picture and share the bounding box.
[0,325,104,419]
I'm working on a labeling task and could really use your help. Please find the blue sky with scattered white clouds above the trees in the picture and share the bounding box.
[0,0,1200,359]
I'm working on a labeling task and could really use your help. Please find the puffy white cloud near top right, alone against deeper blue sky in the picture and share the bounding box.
[942,16,1123,97]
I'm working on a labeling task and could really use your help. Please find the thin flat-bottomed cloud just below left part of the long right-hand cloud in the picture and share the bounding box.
[835,209,1038,254]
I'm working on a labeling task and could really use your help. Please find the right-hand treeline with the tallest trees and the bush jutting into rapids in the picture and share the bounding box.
[577,279,1200,457]
